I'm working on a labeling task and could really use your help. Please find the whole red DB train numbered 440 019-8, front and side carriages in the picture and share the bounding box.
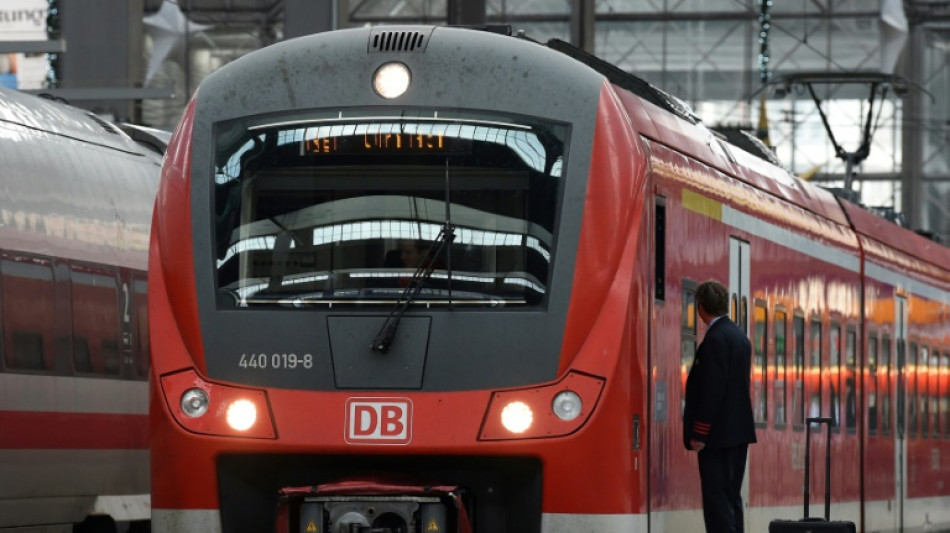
[149,26,950,533]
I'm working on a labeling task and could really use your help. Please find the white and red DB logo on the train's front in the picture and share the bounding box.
[346,398,412,444]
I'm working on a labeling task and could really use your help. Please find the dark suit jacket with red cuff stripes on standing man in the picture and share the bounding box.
[683,316,755,450]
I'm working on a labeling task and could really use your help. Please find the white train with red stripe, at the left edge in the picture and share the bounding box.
[0,85,161,533]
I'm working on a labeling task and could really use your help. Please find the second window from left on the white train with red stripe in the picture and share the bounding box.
[70,265,121,375]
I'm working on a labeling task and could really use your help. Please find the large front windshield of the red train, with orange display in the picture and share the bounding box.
[213,111,568,308]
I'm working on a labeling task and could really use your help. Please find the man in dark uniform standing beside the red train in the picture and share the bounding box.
[683,281,755,533]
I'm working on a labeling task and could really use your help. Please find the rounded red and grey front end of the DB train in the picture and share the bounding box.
[149,27,646,533]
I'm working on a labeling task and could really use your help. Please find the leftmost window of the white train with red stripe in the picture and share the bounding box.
[0,253,56,372]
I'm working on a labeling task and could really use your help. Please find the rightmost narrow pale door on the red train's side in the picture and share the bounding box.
[894,296,907,531]
